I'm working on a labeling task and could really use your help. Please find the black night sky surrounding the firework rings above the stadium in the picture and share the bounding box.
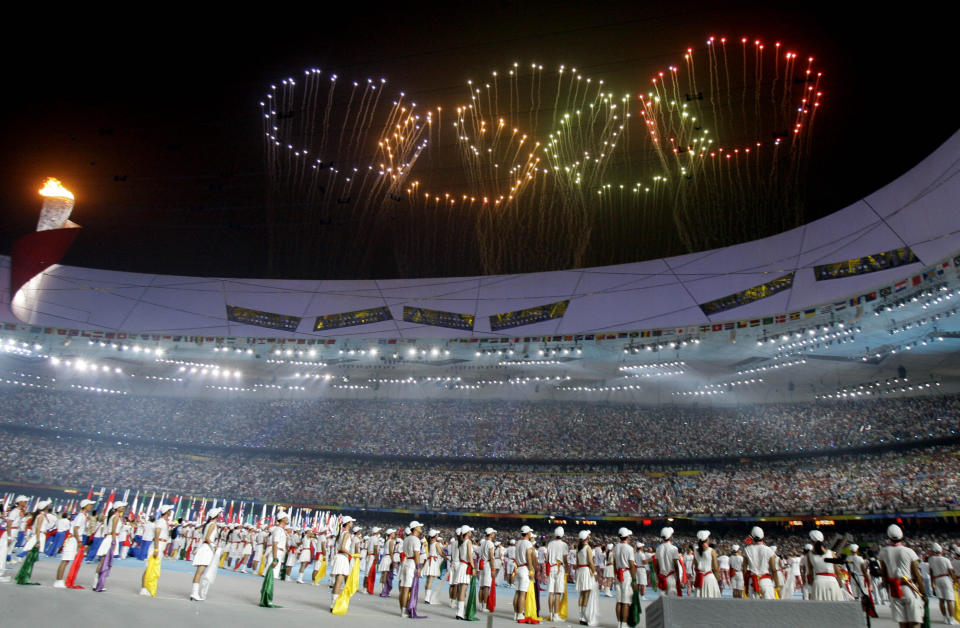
[0,1,957,277]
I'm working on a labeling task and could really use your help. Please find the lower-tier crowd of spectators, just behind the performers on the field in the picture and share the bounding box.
[0,429,960,517]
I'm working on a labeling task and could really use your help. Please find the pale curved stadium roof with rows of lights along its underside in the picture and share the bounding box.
[0,133,960,402]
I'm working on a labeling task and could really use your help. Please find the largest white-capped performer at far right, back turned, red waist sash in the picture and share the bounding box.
[877,524,923,628]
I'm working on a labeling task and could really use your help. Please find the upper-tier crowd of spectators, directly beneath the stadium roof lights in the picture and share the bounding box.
[0,388,960,460]
